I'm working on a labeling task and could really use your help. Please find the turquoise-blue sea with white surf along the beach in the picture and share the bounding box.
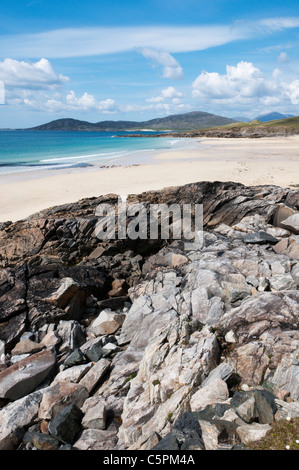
[0,130,185,174]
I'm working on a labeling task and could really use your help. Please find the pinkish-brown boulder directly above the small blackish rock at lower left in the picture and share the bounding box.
[38,382,89,420]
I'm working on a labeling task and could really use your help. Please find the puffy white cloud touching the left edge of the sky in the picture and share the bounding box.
[0,59,69,90]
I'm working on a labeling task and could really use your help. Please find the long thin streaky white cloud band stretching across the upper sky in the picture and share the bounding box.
[1,17,299,60]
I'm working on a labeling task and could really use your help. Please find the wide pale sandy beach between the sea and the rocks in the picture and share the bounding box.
[0,136,299,222]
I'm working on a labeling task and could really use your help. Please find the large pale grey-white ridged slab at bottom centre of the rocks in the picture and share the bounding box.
[119,323,219,446]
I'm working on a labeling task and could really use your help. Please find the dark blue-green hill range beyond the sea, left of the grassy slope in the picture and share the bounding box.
[26,111,236,132]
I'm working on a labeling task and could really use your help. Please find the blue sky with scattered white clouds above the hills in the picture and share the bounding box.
[0,0,299,128]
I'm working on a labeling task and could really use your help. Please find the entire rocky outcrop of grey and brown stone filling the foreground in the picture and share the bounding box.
[0,183,299,450]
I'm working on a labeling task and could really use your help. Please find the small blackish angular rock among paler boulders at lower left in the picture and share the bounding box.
[49,403,83,444]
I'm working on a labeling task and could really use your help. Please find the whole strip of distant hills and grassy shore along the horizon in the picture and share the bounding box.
[17,111,298,137]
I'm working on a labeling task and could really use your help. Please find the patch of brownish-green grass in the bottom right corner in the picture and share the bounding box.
[247,418,299,450]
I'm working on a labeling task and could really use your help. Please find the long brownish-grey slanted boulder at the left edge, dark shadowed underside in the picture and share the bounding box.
[0,351,55,400]
